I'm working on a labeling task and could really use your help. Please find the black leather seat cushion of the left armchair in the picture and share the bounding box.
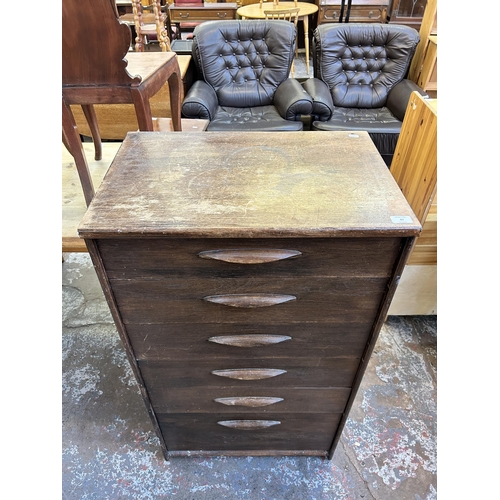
[207,105,304,132]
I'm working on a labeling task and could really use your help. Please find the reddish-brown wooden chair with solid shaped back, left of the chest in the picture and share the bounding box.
[62,0,182,205]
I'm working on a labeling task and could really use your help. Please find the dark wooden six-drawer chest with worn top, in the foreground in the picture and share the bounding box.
[79,132,421,458]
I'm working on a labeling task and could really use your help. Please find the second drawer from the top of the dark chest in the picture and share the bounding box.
[111,278,388,324]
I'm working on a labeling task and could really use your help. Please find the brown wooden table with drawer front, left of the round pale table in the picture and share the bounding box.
[168,2,237,38]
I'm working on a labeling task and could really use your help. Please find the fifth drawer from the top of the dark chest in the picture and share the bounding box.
[145,385,351,418]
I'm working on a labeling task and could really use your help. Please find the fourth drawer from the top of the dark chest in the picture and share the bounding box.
[139,357,360,388]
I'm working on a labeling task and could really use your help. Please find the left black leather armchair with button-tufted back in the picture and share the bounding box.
[182,20,312,131]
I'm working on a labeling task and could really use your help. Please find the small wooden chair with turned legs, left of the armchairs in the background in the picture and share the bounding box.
[132,0,171,52]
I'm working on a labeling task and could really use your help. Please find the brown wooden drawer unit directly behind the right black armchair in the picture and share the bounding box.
[316,0,389,24]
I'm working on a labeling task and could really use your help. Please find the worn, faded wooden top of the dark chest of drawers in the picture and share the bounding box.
[79,131,421,238]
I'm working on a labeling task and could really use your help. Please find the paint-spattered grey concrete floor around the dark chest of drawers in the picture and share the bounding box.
[62,254,437,500]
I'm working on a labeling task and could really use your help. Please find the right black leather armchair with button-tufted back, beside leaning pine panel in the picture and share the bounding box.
[303,23,426,166]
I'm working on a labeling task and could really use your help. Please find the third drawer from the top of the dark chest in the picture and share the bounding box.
[127,322,371,360]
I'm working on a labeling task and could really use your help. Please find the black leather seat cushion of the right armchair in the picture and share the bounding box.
[313,107,401,134]
